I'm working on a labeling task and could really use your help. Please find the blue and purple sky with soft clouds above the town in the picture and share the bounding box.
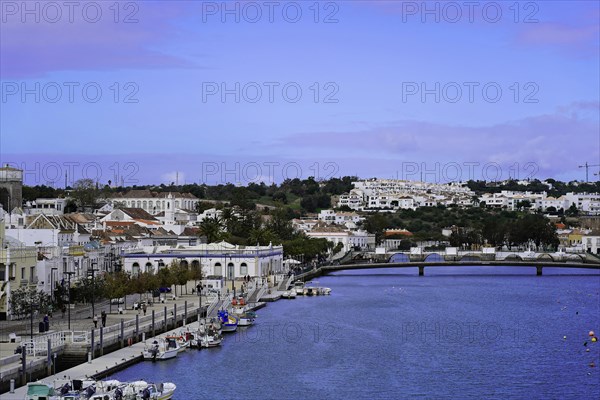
[0,0,600,187]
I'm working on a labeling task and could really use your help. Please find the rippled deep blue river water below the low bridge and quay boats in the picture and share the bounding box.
[113,267,600,400]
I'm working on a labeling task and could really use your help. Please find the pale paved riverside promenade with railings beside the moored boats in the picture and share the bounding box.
[0,281,276,399]
